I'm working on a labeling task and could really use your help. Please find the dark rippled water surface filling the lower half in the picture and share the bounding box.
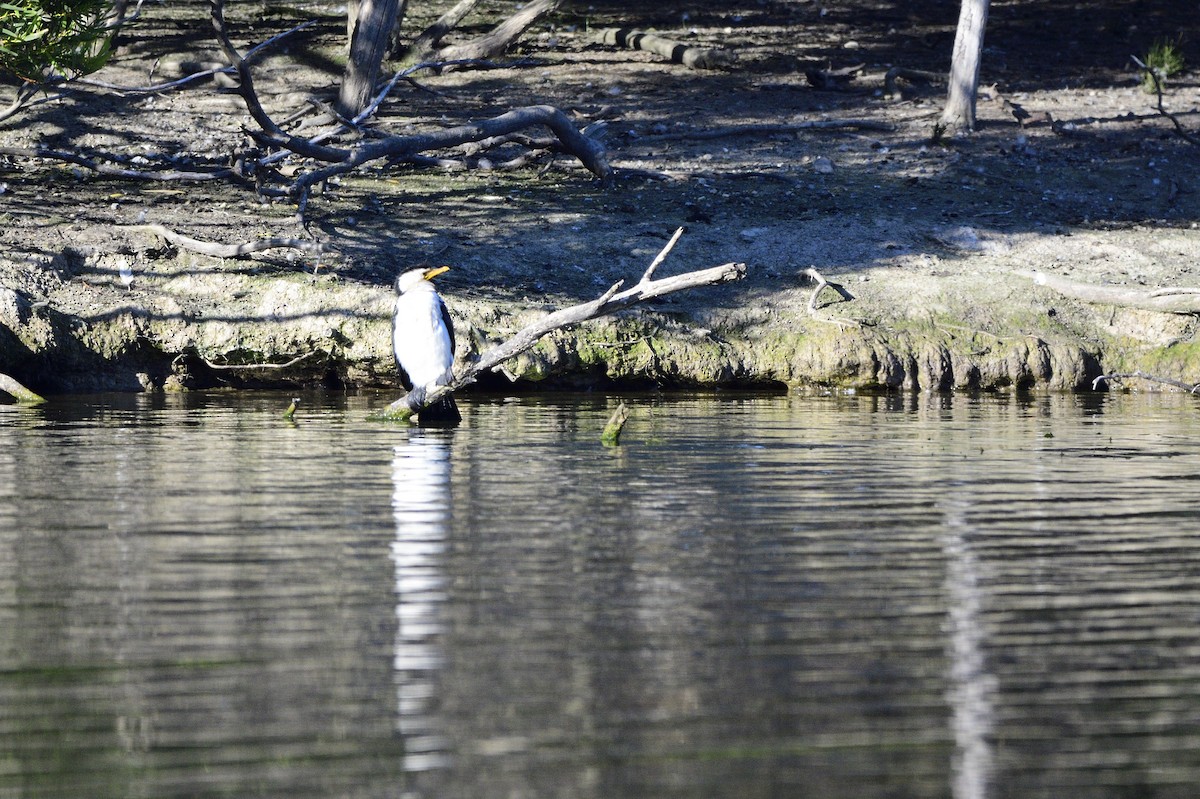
[0,394,1200,799]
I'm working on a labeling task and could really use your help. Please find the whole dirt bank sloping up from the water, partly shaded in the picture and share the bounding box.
[0,1,1200,391]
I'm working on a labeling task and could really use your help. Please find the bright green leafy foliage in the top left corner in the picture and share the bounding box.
[0,0,112,80]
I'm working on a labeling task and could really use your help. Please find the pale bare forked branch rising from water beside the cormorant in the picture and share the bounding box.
[376,257,746,421]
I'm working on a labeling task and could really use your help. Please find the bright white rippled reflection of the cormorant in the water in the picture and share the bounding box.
[391,429,450,771]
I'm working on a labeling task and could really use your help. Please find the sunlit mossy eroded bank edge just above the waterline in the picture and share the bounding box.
[0,223,1200,392]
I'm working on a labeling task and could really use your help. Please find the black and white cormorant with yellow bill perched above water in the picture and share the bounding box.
[391,266,462,426]
